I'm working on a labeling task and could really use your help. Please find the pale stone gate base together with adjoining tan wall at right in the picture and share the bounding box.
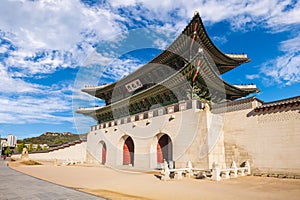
[86,98,300,174]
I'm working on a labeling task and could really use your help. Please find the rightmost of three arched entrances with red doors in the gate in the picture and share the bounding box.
[157,134,173,163]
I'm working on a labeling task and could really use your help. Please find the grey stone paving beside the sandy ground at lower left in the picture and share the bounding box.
[0,160,104,200]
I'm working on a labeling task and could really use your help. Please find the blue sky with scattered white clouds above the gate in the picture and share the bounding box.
[0,0,300,138]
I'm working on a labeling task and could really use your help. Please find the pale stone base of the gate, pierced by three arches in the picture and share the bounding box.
[87,106,225,169]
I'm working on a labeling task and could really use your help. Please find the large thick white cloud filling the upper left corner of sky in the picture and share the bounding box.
[0,0,123,76]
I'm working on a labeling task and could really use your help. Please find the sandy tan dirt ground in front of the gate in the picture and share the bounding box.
[10,163,300,200]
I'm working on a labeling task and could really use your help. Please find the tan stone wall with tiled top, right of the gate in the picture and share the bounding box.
[224,101,300,174]
